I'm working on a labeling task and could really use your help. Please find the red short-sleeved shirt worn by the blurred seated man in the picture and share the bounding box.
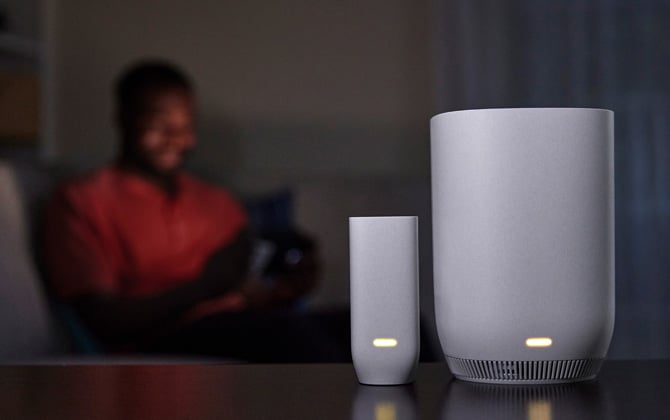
[45,165,247,300]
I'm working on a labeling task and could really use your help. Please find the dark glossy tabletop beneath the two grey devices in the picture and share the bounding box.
[0,361,670,420]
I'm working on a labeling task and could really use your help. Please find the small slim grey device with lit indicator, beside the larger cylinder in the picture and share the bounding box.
[349,216,419,385]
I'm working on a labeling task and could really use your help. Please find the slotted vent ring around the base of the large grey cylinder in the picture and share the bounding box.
[447,356,603,383]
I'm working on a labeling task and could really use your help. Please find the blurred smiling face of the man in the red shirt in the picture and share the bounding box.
[134,89,195,175]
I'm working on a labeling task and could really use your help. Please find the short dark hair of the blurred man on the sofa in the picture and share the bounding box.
[115,60,193,124]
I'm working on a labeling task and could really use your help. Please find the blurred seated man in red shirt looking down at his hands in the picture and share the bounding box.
[45,61,334,358]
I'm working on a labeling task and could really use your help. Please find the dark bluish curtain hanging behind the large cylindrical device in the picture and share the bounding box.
[433,0,670,358]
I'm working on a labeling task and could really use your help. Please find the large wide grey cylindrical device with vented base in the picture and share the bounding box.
[431,108,614,383]
